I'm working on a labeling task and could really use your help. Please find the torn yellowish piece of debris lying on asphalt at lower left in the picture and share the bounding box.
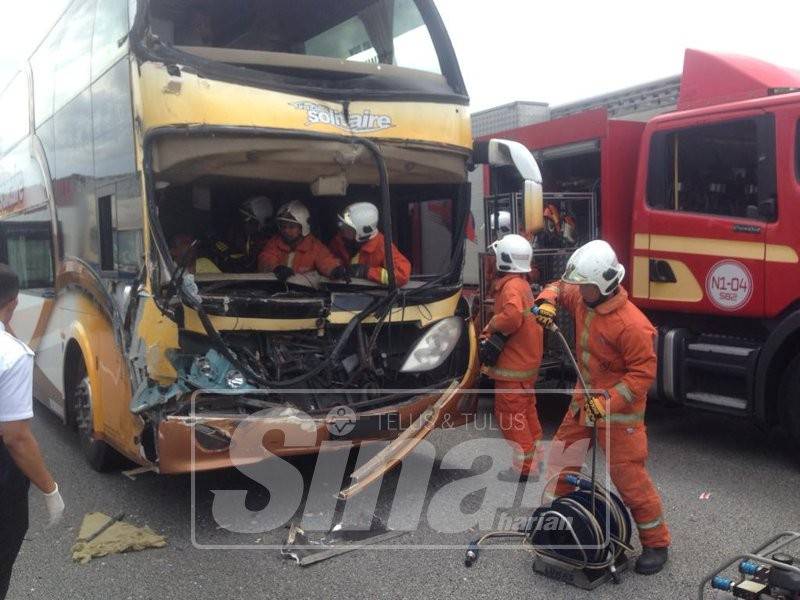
[72,513,167,565]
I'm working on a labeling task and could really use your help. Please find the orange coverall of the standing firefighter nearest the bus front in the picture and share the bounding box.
[481,274,543,475]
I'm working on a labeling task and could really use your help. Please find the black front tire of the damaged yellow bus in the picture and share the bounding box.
[67,357,121,473]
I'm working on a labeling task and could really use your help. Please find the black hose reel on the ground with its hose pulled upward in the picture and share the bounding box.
[464,316,633,589]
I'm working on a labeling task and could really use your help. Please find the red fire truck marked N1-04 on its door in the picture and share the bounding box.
[486,50,800,441]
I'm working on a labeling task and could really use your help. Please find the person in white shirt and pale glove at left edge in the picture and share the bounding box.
[0,264,64,600]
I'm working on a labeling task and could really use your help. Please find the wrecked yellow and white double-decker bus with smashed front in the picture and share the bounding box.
[0,0,542,480]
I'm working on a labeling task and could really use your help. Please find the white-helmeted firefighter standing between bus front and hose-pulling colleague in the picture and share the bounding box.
[481,234,543,482]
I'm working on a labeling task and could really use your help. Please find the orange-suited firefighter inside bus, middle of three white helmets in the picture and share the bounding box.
[258,200,346,281]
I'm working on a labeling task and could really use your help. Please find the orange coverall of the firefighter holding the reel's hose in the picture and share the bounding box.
[539,283,670,548]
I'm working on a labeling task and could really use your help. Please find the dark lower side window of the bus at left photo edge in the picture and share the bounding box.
[0,204,53,290]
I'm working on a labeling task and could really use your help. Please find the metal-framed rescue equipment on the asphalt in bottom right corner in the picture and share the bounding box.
[697,531,800,600]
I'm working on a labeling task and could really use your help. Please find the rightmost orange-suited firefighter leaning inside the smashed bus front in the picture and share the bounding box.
[330,202,411,287]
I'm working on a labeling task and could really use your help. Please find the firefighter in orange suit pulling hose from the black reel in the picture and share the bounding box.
[536,240,670,575]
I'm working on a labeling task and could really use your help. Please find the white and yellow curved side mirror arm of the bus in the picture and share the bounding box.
[473,139,544,234]
